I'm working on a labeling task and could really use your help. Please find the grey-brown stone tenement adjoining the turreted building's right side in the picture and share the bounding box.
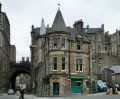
[84,24,120,80]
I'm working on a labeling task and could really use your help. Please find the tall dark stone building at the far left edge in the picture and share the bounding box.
[0,3,10,92]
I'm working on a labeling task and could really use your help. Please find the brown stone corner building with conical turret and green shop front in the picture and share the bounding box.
[30,9,90,95]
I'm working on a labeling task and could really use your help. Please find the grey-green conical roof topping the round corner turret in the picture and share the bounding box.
[51,9,66,31]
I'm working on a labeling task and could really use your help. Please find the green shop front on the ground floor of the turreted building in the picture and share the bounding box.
[71,74,84,93]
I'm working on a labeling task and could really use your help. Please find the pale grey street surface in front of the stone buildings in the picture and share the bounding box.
[0,91,120,99]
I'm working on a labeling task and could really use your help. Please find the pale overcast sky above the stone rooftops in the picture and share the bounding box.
[0,0,120,61]
